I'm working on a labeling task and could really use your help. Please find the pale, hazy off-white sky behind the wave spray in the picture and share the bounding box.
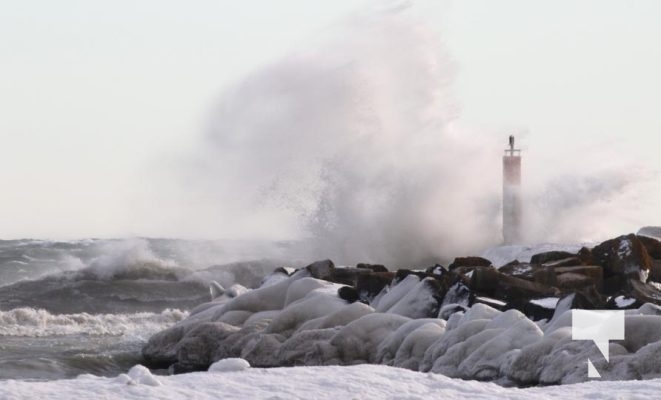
[0,0,661,239]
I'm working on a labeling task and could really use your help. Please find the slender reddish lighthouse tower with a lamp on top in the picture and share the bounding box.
[503,135,521,244]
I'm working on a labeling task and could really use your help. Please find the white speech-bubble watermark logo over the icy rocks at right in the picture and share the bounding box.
[571,309,624,378]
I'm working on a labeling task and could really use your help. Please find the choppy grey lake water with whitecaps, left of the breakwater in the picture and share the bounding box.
[0,239,291,380]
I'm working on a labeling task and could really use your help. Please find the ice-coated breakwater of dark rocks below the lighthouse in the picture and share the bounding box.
[143,234,661,385]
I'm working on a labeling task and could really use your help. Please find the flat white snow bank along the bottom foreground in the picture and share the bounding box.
[0,364,661,400]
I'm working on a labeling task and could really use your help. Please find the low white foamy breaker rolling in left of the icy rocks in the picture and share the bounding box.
[0,307,188,337]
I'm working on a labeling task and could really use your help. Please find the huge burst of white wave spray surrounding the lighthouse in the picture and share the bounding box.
[135,3,652,267]
